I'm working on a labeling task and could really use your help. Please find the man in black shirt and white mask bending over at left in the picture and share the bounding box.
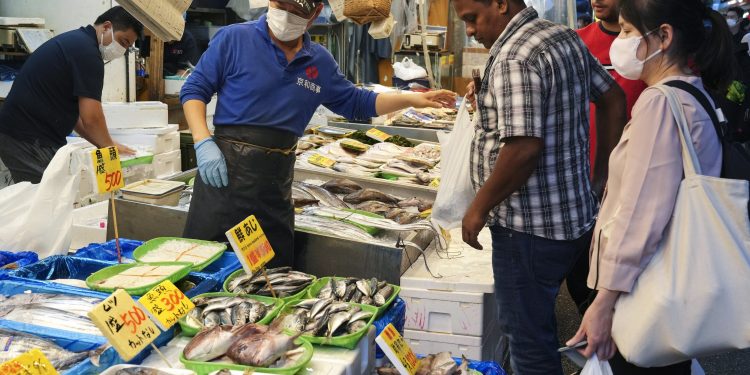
[0,6,143,183]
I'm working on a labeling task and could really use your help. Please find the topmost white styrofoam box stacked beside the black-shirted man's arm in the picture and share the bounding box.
[102,102,169,128]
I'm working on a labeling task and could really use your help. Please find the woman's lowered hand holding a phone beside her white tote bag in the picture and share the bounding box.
[565,289,620,361]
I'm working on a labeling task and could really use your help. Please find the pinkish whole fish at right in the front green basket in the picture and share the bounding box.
[227,332,298,367]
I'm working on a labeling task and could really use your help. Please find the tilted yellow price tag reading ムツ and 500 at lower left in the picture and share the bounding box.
[88,289,161,361]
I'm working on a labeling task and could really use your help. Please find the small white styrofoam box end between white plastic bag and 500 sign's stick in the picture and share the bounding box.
[70,201,109,249]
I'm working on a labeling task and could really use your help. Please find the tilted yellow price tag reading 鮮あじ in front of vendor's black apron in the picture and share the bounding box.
[226,215,275,273]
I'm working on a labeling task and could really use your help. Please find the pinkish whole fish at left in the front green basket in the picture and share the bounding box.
[182,324,268,362]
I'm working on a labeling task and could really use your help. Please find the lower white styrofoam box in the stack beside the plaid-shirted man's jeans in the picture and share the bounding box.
[404,327,505,363]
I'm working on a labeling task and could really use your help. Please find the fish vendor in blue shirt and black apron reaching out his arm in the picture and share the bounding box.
[180,0,455,266]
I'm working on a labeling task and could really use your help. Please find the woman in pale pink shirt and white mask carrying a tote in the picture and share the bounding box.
[567,0,734,375]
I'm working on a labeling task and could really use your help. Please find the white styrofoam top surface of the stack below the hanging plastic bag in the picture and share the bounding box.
[401,228,495,293]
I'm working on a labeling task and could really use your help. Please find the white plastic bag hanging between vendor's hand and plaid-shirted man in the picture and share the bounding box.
[432,98,476,229]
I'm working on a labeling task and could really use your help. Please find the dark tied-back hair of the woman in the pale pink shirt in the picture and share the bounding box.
[620,0,737,92]
